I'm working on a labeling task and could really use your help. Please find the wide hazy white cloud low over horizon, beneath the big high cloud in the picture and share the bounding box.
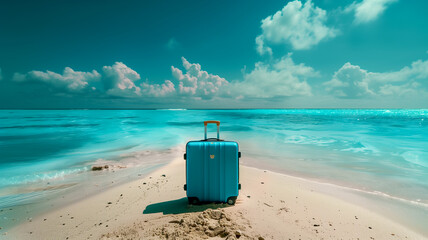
[228,54,319,98]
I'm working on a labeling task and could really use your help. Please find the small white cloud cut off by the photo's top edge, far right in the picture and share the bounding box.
[345,0,397,24]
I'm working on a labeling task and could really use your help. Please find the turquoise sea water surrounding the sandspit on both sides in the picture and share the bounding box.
[0,109,428,232]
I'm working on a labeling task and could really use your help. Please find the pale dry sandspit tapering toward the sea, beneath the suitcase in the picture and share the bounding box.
[5,160,425,239]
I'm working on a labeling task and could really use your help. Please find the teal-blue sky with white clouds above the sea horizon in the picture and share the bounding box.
[0,0,428,108]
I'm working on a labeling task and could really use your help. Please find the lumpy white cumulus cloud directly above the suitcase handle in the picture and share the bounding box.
[171,57,229,99]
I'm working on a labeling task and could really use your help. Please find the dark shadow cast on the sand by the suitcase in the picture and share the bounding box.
[143,197,230,215]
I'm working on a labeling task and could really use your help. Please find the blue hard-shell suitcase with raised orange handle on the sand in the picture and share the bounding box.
[184,121,241,205]
